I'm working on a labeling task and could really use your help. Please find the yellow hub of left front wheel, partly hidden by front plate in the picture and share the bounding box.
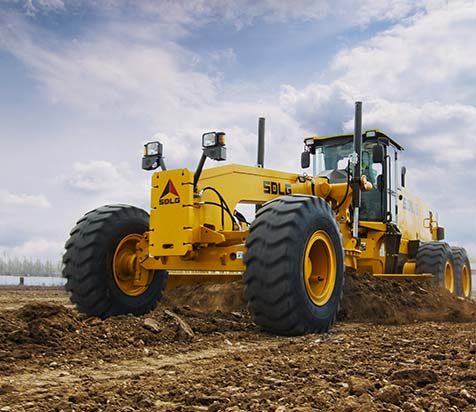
[112,233,153,296]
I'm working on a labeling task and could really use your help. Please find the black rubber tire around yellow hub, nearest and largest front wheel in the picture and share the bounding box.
[244,196,344,335]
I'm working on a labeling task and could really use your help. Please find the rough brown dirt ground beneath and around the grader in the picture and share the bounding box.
[0,276,476,412]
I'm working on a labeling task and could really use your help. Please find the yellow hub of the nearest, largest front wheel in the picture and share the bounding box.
[303,230,337,306]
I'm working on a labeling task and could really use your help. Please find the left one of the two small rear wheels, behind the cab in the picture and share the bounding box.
[415,242,456,293]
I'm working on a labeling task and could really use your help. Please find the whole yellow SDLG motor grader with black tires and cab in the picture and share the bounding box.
[63,102,471,335]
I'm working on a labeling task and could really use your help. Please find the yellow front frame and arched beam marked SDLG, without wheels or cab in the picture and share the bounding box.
[136,164,432,284]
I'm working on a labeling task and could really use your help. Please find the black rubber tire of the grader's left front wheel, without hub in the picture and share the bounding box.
[63,205,166,318]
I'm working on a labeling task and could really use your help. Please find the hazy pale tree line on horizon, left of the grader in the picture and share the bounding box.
[0,255,61,276]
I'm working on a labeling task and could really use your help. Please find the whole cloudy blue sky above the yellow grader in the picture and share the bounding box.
[0,0,476,259]
